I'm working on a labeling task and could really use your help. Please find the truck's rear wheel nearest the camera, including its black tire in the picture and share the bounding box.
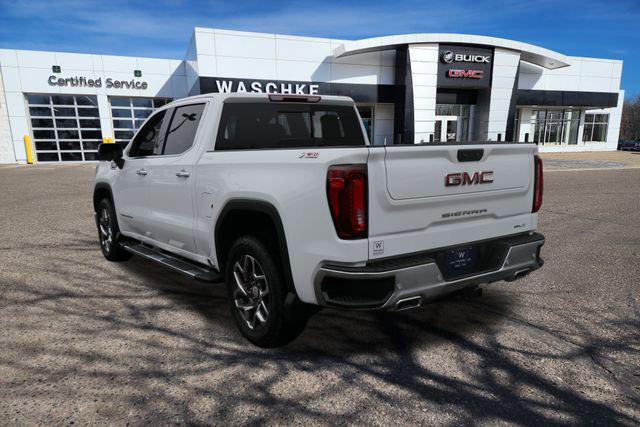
[225,236,311,348]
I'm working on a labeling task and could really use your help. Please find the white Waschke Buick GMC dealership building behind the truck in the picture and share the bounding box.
[0,28,624,163]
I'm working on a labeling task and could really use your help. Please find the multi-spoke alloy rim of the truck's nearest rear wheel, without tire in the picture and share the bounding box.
[233,254,269,329]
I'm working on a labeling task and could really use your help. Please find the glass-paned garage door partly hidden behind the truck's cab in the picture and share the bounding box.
[109,96,171,147]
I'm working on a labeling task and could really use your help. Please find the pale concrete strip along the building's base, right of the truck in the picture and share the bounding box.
[540,151,640,171]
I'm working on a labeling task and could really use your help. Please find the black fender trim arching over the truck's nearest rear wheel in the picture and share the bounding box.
[213,199,297,295]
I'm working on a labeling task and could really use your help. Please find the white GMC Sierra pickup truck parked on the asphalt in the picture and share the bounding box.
[93,94,544,347]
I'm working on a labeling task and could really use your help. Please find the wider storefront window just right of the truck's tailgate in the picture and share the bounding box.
[531,109,580,145]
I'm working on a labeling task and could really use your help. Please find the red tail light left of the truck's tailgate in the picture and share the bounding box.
[327,165,367,239]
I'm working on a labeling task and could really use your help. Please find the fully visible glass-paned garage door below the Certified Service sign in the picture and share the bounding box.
[27,94,102,162]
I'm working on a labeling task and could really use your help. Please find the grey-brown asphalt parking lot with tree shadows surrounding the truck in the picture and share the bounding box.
[0,160,640,425]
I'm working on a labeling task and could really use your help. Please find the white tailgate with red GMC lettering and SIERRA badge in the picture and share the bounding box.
[368,143,537,259]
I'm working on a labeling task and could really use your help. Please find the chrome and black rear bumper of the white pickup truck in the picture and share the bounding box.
[314,233,544,310]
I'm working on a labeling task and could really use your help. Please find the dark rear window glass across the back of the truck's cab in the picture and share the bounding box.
[215,103,365,150]
